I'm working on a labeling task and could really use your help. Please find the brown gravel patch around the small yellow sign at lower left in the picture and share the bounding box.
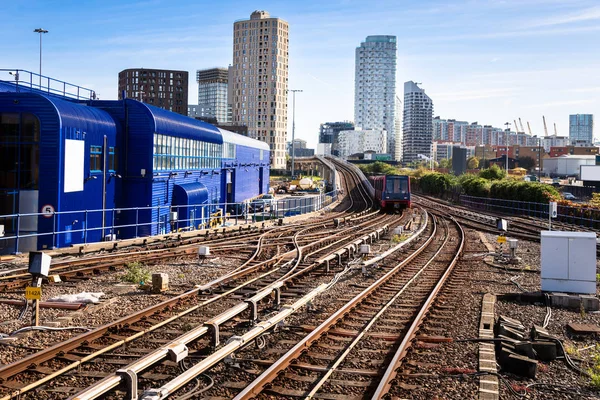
[0,257,239,364]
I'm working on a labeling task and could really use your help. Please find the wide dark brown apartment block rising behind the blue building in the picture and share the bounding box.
[119,68,189,115]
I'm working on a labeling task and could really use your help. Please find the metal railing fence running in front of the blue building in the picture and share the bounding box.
[0,190,337,254]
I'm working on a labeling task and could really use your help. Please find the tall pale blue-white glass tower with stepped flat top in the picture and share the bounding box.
[354,35,400,160]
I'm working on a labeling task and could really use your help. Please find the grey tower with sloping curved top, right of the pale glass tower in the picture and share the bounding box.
[402,81,433,163]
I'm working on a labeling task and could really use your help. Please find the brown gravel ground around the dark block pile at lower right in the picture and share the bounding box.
[380,225,600,399]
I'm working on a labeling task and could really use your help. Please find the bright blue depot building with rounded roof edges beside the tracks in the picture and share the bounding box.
[0,71,270,253]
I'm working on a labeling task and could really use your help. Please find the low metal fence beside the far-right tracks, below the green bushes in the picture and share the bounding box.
[459,195,600,229]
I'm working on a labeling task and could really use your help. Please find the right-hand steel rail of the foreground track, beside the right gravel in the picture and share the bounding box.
[373,217,465,399]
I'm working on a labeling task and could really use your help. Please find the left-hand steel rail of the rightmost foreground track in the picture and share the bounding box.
[234,209,437,400]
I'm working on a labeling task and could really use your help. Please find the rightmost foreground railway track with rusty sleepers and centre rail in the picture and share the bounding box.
[221,211,464,399]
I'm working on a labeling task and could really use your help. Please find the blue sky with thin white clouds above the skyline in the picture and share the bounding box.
[0,0,600,146]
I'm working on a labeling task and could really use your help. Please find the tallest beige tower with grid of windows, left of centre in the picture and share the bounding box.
[229,11,289,169]
